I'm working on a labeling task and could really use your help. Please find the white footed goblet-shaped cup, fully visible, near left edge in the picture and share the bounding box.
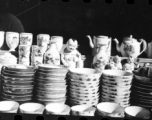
[6,32,19,51]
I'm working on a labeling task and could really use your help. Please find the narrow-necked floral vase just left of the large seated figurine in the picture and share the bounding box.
[44,43,60,65]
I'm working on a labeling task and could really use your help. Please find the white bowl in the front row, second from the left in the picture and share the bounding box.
[19,102,45,114]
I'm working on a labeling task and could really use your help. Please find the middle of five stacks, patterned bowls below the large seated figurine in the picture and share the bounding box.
[67,68,101,106]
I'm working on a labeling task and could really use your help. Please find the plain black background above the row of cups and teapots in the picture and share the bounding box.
[6,0,152,55]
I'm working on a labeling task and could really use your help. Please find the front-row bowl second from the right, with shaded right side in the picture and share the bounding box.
[96,102,125,118]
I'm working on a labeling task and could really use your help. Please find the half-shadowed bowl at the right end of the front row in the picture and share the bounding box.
[125,106,150,119]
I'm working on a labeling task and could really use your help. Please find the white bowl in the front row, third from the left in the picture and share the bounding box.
[45,103,71,115]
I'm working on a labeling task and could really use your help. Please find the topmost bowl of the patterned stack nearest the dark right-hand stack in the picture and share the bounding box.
[102,70,133,80]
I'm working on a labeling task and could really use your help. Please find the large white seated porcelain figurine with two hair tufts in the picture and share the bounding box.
[61,39,83,68]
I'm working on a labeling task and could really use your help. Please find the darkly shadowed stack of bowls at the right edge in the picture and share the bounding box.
[131,75,152,109]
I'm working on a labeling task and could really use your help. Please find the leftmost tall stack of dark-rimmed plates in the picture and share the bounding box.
[1,65,35,103]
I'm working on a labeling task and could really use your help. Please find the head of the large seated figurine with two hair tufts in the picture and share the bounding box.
[67,39,78,52]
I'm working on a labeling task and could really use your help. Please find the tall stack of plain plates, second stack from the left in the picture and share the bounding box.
[35,64,68,105]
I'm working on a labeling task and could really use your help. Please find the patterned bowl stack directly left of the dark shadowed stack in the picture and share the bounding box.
[101,70,133,107]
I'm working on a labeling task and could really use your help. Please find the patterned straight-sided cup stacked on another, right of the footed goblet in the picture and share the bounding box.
[20,33,33,45]
